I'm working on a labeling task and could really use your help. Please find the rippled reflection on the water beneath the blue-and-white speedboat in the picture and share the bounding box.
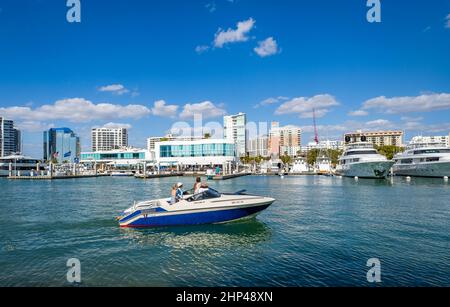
[121,219,272,249]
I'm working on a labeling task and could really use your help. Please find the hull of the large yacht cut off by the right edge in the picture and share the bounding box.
[393,161,450,178]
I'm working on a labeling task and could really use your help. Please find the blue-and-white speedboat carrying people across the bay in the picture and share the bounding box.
[117,188,275,228]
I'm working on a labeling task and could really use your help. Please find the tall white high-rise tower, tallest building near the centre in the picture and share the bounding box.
[223,113,247,157]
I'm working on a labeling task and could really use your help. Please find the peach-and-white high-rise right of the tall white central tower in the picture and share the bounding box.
[269,122,302,156]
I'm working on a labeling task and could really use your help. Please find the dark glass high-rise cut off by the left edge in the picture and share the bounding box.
[0,117,22,157]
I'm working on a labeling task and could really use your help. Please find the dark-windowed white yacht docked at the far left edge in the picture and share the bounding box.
[0,155,45,177]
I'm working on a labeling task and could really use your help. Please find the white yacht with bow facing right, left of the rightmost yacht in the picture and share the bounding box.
[337,142,394,178]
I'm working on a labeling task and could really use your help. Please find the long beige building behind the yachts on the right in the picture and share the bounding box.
[344,130,403,147]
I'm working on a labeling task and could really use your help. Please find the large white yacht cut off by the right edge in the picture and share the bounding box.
[393,143,450,178]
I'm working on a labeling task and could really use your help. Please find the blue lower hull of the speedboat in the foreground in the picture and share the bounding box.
[119,203,272,228]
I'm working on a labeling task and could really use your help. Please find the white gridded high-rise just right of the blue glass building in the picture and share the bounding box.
[91,128,128,152]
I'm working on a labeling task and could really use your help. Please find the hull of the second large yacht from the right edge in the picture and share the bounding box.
[339,161,394,179]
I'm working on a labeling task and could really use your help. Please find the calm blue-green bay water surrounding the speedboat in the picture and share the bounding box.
[0,176,450,286]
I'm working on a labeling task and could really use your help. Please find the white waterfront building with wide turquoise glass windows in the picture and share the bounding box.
[155,139,238,168]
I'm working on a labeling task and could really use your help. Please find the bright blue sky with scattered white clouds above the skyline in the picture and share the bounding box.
[0,0,450,157]
